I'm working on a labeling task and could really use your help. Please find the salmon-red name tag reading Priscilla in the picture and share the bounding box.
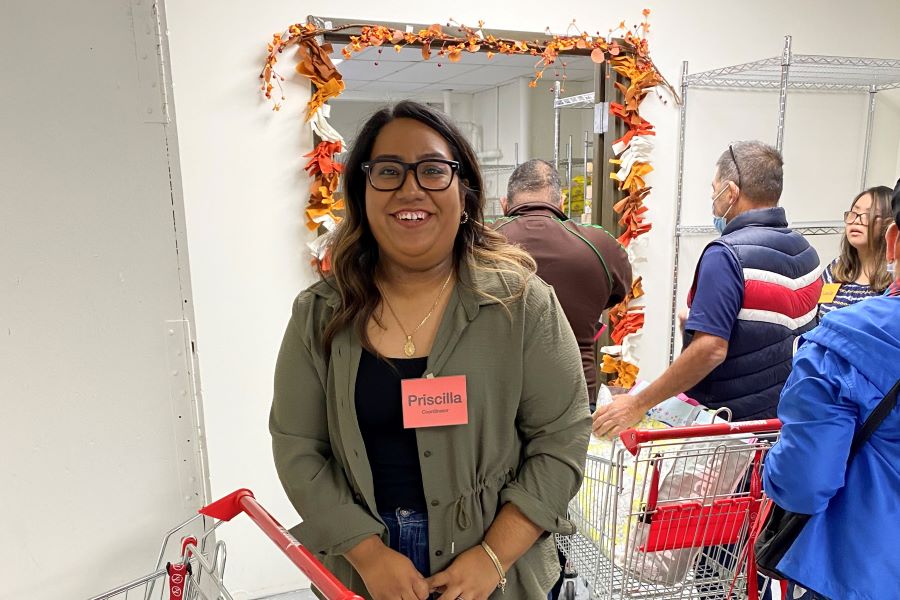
[400,375,469,429]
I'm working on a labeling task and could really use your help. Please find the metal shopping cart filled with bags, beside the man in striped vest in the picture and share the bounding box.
[557,419,781,600]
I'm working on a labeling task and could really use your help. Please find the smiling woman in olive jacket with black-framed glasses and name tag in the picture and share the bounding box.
[270,102,590,600]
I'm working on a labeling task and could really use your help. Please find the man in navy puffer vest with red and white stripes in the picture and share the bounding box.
[594,141,822,437]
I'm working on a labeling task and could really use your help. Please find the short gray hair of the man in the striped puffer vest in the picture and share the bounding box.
[716,140,784,206]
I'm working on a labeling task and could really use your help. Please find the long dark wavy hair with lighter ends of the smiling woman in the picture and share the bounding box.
[323,100,536,355]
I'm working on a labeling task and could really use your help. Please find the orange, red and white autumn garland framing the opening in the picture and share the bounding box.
[260,14,675,387]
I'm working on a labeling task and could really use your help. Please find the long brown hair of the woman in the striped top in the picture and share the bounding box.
[832,185,893,292]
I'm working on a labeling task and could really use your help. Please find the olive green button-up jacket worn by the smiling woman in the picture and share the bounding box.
[269,265,591,600]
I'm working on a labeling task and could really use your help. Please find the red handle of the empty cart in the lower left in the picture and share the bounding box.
[200,489,363,600]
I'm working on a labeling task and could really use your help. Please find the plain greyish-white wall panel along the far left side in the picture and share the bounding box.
[0,0,203,600]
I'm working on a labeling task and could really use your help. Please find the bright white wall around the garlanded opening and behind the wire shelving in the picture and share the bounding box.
[162,0,900,591]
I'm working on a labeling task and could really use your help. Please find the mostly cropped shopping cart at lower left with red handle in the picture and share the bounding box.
[90,489,363,600]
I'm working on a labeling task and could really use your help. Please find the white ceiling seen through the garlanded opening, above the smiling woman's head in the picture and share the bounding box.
[331,44,594,100]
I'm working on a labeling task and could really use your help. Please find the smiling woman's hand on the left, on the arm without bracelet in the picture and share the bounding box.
[344,537,431,600]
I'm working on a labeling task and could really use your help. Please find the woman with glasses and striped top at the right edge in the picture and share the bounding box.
[819,185,892,319]
